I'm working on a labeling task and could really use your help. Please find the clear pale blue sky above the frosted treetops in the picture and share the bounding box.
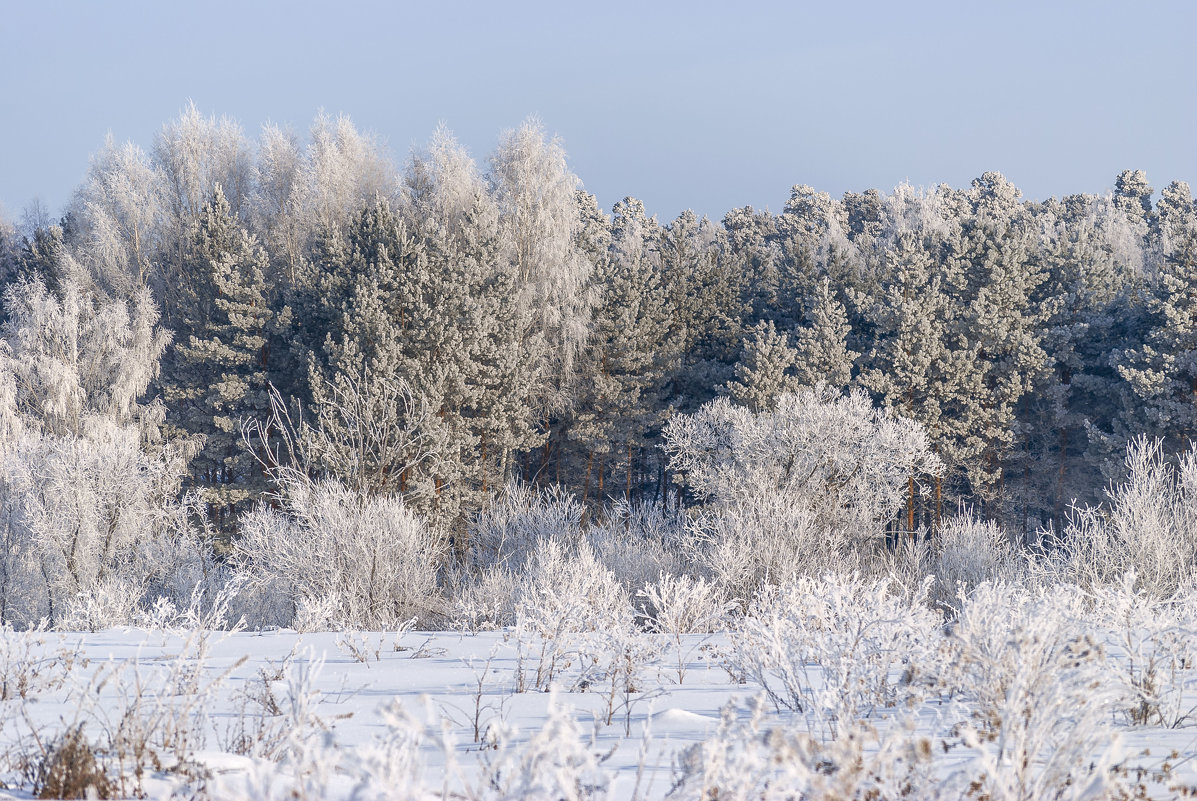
[0,0,1197,222]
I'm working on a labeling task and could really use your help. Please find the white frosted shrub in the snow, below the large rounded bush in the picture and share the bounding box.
[731,575,942,733]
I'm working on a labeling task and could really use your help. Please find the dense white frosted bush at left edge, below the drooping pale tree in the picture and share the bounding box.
[0,418,211,627]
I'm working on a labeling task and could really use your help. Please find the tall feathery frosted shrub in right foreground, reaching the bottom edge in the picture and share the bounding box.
[947,574,1124,799]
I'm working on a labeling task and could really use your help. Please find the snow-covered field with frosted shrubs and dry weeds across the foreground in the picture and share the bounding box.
[7,578,1197,801]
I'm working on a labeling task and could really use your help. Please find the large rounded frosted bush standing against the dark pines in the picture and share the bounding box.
[664,387,942,589]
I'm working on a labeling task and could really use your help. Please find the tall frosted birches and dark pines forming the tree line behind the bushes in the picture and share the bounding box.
[0,101,1197,533]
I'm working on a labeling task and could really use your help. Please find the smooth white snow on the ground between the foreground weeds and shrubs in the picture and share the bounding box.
[0,629,1197,799]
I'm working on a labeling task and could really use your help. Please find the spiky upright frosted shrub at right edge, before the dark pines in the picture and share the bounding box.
[1051,438,1197,597]
